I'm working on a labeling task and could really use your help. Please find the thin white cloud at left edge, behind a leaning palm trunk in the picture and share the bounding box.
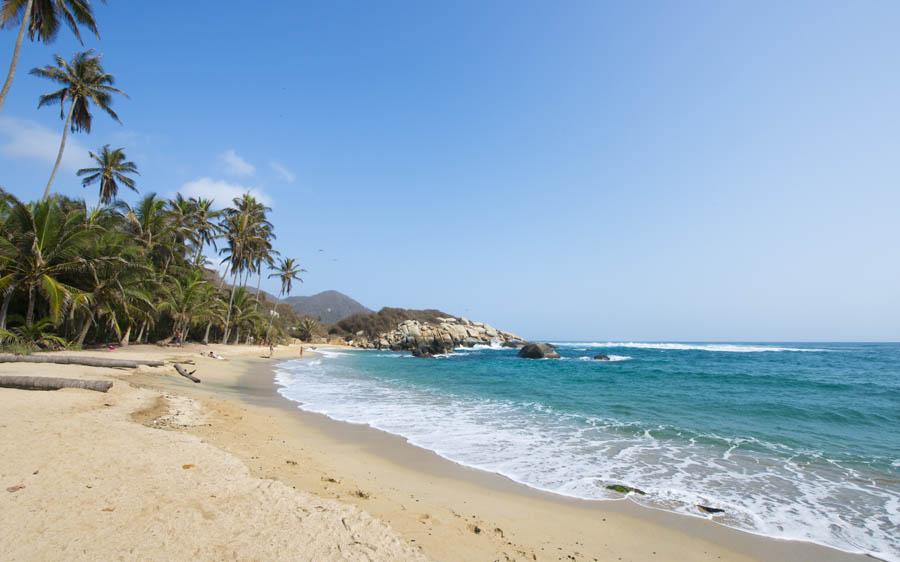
[0,117,91,171]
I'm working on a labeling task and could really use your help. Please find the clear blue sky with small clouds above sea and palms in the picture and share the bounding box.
[0,0,900,341]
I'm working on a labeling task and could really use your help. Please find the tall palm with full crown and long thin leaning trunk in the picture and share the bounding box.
[31,50,127,199]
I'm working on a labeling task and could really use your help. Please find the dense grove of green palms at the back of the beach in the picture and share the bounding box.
[0,190,300,350]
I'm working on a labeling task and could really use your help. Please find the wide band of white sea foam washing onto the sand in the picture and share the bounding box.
[276,352,900,561]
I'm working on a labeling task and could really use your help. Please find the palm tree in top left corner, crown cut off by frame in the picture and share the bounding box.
[0,0,100,111]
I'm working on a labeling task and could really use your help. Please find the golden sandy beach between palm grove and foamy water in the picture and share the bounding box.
[0,345,863,561]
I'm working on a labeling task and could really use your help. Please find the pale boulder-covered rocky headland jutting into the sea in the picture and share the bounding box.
[351,316,525,357]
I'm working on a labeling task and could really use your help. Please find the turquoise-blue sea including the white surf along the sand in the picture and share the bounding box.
[277,342,900,561]
